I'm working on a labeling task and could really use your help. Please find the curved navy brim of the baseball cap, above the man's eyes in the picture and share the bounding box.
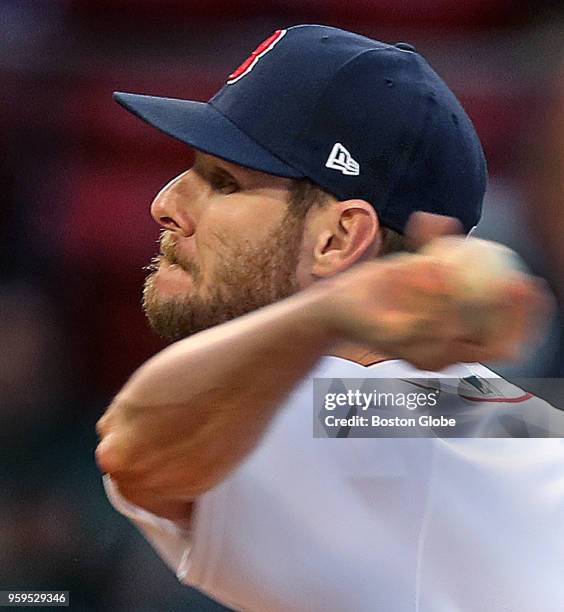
[114,92,303,178]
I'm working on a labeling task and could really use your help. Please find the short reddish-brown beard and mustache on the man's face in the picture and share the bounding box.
[143,212,304,342]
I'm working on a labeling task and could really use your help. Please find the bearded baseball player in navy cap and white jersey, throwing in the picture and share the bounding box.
[97,25,564,612]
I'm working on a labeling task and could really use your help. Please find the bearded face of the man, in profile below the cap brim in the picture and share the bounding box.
[143,153,304,341]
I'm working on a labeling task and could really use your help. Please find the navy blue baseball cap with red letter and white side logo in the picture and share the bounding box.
[114,25,487,232]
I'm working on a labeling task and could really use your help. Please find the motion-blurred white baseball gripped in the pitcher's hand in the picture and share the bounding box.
[420,236,527,337]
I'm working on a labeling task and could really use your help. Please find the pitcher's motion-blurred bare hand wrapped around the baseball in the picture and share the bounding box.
[317,254,547,370]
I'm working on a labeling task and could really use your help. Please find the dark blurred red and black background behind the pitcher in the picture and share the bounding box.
[0,0,564,611]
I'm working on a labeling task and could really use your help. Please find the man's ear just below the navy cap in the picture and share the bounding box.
[311,200,380,278]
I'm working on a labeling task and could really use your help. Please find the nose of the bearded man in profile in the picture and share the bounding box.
[151,172,195,236]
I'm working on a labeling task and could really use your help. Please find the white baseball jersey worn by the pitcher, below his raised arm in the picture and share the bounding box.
[105,357,564,612]
